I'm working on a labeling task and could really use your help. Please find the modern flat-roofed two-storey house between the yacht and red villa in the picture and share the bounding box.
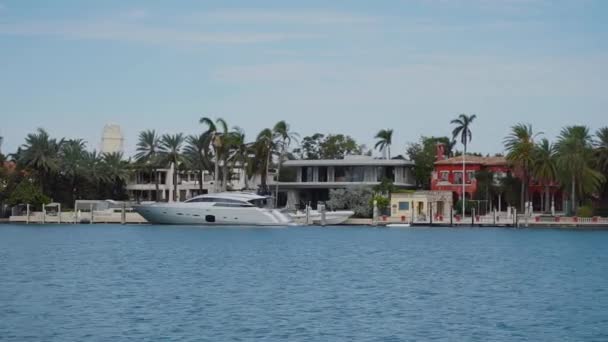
[270,156,416,208]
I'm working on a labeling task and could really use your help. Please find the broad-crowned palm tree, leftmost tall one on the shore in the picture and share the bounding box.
[17,128,64,193]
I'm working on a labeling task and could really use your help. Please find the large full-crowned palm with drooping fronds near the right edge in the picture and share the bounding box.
[556,126,605,213]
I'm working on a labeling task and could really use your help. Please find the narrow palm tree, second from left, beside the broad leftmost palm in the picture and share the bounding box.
[60,139,86,203]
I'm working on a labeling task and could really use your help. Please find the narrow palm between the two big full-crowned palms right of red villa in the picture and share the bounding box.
[532,138,557,212]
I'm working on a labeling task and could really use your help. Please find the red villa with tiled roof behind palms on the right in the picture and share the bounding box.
[431,146,563,211]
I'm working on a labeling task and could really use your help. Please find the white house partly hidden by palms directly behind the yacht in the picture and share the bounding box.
[126,164,274,202]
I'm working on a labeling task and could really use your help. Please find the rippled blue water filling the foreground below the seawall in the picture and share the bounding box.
[0,225,608,341]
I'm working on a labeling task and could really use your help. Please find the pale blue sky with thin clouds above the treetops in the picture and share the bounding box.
[0,0,608,154]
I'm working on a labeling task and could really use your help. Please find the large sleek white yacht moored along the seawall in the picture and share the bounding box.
[133,192,293,226]
